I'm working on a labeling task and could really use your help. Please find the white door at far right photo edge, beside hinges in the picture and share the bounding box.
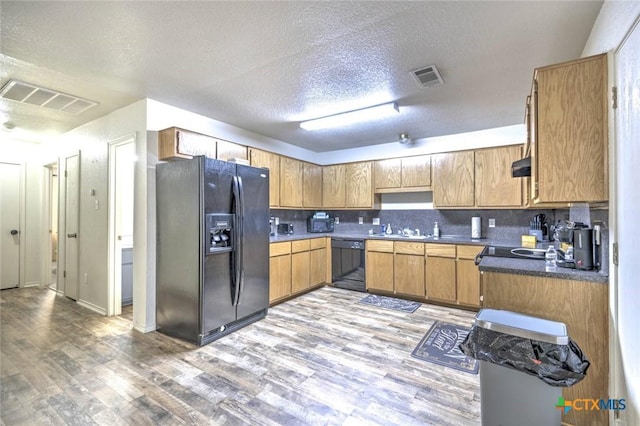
[613,15,640,425]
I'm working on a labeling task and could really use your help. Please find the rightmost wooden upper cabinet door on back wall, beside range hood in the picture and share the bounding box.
[475,145,522,207]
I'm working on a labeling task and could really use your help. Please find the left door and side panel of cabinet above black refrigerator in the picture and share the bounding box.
[158,127,216,161]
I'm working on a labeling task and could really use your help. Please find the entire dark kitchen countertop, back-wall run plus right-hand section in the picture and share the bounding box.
[270,232,609,284]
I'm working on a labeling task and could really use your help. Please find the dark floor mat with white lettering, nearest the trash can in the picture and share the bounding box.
[411,321,479,374]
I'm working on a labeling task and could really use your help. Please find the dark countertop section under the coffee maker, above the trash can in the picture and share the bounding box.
[478,256,609,284]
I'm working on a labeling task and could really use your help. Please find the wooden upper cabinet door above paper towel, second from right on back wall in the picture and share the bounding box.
[433,151,475,207]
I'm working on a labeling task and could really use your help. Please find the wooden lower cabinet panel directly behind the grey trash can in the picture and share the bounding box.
[482,272,609,426]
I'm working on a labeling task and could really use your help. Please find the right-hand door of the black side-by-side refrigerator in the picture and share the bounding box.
[236,164,269,319]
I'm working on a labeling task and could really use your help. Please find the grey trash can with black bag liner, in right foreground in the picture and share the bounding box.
[460,309,589,426]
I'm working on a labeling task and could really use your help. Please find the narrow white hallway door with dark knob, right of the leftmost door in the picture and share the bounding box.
[63,155,80,300]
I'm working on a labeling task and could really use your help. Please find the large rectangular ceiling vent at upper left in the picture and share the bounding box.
[0,80,98,114]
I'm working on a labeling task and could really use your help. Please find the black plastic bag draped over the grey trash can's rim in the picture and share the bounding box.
[460,326,591,387]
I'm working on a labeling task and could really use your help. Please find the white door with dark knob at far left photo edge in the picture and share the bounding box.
[0,163,21,289]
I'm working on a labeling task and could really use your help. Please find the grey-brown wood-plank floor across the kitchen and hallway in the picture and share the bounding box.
[0,287,480,425]
